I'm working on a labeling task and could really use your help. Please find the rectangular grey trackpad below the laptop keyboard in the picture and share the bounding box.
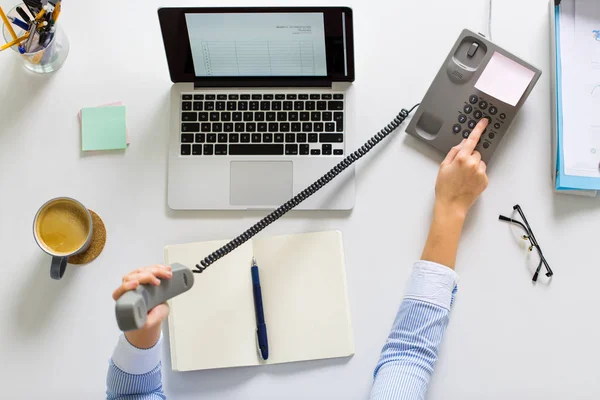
[229,161,294,206]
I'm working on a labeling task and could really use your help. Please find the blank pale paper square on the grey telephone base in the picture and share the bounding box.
[475,52,535,107]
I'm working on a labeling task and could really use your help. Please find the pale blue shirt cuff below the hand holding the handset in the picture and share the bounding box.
[112,333,162,375]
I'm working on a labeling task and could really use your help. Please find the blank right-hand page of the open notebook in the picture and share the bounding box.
[253,232,354,364]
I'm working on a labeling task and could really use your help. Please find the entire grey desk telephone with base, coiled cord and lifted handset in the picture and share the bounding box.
[116,30,541,331]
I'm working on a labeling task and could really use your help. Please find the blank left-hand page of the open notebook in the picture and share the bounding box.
[165,242,256,371]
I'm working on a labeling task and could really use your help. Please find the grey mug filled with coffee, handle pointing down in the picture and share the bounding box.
[33,197,93,279]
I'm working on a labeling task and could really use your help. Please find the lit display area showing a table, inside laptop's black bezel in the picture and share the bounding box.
[185,13,327,77]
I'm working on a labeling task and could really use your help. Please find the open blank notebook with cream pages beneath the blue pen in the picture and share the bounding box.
[165,232,354,371]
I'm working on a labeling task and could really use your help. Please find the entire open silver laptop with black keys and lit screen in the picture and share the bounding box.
[158,7,356,210]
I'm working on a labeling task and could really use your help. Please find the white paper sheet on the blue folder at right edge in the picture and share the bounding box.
[560,0,600,178]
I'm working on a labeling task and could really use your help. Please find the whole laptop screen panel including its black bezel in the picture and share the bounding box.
[158,7,354,86]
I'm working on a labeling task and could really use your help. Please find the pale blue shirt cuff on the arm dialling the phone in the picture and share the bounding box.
[404,261,458,310]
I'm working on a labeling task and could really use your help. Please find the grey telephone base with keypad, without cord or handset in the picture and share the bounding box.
[406,29,542,162]
